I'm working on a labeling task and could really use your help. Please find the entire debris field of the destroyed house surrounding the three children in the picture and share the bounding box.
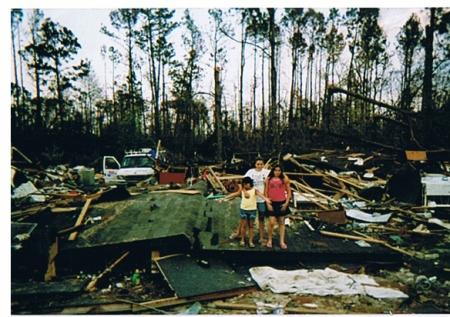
[11,139,450,314]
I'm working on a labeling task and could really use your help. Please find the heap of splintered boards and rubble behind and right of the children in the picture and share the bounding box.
[204,150,450,275]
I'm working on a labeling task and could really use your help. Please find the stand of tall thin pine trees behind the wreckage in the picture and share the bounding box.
[11,8,450,165]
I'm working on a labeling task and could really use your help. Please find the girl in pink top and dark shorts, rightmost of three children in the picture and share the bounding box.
[264,164,292,249]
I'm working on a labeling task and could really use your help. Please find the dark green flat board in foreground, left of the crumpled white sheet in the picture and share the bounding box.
[156,254,256,298]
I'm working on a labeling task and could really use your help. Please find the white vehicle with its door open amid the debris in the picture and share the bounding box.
[103,149,156,186]
